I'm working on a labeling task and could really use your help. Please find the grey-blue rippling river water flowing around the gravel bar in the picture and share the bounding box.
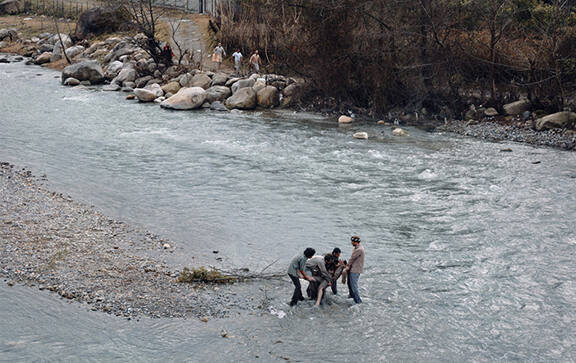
[0,59,576,362]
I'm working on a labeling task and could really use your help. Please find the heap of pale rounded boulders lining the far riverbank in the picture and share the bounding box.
[0,29,303,111]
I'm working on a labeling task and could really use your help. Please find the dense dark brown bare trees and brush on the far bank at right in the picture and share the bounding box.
[214,0,576,116]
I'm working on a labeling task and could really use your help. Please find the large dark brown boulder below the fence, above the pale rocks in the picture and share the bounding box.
[76,6,133,37]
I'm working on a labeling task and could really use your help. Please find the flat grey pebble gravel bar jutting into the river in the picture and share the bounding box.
[0,162,258,320]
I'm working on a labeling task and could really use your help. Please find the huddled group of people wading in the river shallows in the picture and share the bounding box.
[288,235,364,306]
